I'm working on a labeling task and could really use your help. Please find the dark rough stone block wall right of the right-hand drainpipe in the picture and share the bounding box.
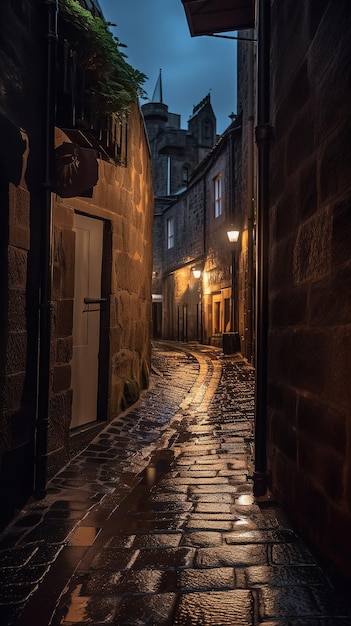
[268,0,351,578]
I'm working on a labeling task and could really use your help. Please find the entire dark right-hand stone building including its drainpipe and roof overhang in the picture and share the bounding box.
[182,0,351,584]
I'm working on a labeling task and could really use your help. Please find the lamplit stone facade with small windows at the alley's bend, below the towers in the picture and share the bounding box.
[162,119,253,354]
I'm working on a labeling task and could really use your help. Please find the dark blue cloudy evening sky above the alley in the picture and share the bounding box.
[99,0,236,134]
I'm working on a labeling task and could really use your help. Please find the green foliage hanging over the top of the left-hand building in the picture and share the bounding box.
[59,0,146,117]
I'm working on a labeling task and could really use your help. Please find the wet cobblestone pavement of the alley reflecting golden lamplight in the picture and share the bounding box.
[0,342,351,626]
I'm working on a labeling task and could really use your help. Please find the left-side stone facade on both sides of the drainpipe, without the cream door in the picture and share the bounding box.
[0,0,153,525]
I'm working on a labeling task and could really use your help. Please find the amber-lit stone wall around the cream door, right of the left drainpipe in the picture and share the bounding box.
[49,105,153,468]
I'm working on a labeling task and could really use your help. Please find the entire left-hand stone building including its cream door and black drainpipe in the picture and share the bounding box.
[0,0,153,526]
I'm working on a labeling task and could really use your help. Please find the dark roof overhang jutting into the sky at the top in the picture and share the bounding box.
[182,0,255,37]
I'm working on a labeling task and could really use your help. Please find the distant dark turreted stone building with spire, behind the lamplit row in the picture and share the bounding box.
[142,71,223,337]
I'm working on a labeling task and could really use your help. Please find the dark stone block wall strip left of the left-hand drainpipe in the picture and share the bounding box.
[0,0,43,525]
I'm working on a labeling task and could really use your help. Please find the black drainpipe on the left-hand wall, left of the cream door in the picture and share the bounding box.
[34,0,58,499]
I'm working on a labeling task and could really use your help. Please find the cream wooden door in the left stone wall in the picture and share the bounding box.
[71,213,103,428]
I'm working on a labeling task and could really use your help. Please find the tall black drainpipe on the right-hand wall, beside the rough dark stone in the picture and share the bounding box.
[254,0,272,497]
